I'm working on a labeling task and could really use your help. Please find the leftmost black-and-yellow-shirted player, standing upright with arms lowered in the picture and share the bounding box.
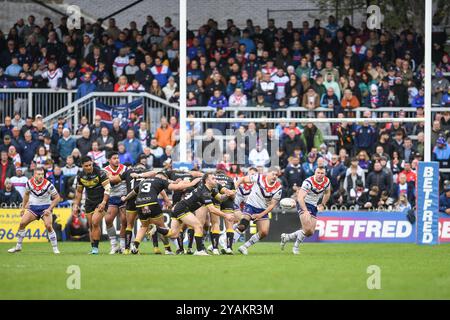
[72,156,111,254]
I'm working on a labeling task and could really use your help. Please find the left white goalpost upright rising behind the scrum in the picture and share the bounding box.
[179,0,187,162]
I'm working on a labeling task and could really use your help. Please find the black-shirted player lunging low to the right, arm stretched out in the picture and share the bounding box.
[150,173,234,256]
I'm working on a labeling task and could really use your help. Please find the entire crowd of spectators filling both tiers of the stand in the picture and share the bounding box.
[0,16,450,209]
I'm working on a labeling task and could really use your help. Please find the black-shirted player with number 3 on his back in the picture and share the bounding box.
[123,173,200,253]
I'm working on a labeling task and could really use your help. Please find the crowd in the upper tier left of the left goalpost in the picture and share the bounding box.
[0,15,179,103]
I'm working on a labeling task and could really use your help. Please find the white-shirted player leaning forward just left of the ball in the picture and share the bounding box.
[235,167,282,255]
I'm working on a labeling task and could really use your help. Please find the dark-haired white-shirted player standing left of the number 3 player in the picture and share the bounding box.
[104,151,127,254]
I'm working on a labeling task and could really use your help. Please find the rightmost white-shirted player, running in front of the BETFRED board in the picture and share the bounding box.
[281,167,331,254]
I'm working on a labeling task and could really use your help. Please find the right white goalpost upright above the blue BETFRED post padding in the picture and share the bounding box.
[424,0,433,162]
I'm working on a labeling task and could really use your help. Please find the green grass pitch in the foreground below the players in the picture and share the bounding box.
[0,242,450,300]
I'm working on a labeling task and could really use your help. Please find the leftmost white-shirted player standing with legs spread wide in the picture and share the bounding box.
[8,168,61,254]
